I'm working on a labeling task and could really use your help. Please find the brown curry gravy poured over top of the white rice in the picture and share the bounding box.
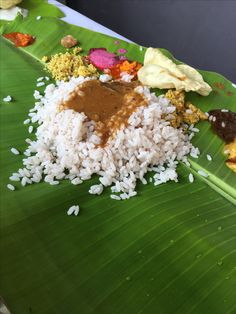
[62,80,147,146]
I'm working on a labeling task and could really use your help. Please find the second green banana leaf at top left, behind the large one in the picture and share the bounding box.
[0,0,64,26]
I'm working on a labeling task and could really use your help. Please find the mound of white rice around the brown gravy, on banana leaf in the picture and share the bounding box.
[15,77,196,199]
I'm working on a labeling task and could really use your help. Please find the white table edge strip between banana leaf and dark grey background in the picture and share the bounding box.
[48,0,131,42]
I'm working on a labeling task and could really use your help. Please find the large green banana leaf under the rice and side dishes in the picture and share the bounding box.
[0,12,236,314]
